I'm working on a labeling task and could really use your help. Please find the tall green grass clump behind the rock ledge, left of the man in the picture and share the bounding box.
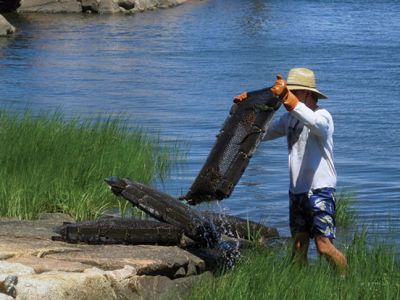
[0,109,174,220]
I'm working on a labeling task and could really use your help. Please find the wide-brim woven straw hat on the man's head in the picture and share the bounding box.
[286,68,328,99]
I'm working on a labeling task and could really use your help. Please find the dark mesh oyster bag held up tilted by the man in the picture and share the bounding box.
[180,88,281,205]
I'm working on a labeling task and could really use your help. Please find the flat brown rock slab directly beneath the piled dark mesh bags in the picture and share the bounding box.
[0,214,206,278]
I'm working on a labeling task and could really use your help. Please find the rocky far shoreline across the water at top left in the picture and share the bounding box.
[0,0,187,37]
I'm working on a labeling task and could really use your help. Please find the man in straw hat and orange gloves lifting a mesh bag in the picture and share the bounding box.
[234,68,347,272]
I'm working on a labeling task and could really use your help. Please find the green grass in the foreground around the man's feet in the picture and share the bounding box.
[187,231,400,300]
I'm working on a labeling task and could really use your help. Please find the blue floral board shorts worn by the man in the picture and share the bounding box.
[289,188,336,239]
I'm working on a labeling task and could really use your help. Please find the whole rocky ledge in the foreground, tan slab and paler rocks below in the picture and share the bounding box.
[0,214,213,300]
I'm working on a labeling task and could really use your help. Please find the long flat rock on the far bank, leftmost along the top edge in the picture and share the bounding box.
[17,0,82,13]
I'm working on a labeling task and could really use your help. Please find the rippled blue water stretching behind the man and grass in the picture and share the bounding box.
[0,0,400,243]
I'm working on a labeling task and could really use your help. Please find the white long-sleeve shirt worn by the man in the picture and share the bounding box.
[263,102,336,194]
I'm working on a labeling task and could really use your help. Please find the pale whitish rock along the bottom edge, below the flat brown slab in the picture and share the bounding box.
[16,268,212,300]
